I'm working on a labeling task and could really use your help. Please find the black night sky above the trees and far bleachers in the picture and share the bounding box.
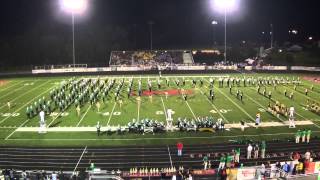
[0,0,320,60]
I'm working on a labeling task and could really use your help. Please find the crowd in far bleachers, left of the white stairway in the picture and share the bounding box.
[110,51,184,66]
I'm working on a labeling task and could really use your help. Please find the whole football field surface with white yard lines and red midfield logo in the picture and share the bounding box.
[0,74,320,146]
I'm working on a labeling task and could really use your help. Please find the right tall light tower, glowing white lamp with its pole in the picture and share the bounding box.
[211,0,238,63]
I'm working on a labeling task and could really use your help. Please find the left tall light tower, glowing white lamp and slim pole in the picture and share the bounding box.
[60,0,88,68]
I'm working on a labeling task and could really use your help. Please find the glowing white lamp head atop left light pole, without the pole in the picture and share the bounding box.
[60,0,88,14]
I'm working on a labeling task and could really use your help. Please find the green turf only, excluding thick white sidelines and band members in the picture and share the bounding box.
[0,74,320,146]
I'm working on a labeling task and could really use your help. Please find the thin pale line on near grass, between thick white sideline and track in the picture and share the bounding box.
[6,131,320,141]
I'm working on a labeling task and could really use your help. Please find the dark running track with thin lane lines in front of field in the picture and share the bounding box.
[0,139,320,171]
